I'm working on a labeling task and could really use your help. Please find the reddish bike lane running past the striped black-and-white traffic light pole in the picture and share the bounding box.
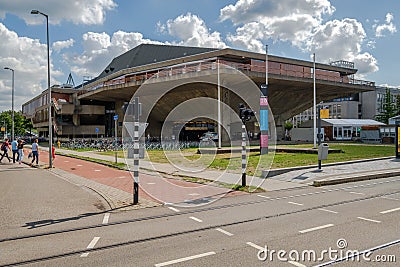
[33,151,245,206]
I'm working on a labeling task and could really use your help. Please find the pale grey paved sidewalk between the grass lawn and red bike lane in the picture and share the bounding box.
[50,149,400,191]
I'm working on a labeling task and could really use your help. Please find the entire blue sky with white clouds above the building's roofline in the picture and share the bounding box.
[0,0,400,110]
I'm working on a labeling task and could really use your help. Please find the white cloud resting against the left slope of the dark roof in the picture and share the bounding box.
[63,31,161,77]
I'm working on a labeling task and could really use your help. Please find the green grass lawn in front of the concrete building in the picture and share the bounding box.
[99,143,395,174]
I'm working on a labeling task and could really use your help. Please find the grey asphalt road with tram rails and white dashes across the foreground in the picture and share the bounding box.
[0,164,400,266]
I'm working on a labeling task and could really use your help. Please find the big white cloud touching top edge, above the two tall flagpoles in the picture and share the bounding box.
[220,0,335,52]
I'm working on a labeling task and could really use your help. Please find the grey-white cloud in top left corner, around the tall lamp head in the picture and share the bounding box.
[0,0,117,25]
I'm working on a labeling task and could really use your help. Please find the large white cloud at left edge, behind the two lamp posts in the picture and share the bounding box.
[0,23,61,110]
